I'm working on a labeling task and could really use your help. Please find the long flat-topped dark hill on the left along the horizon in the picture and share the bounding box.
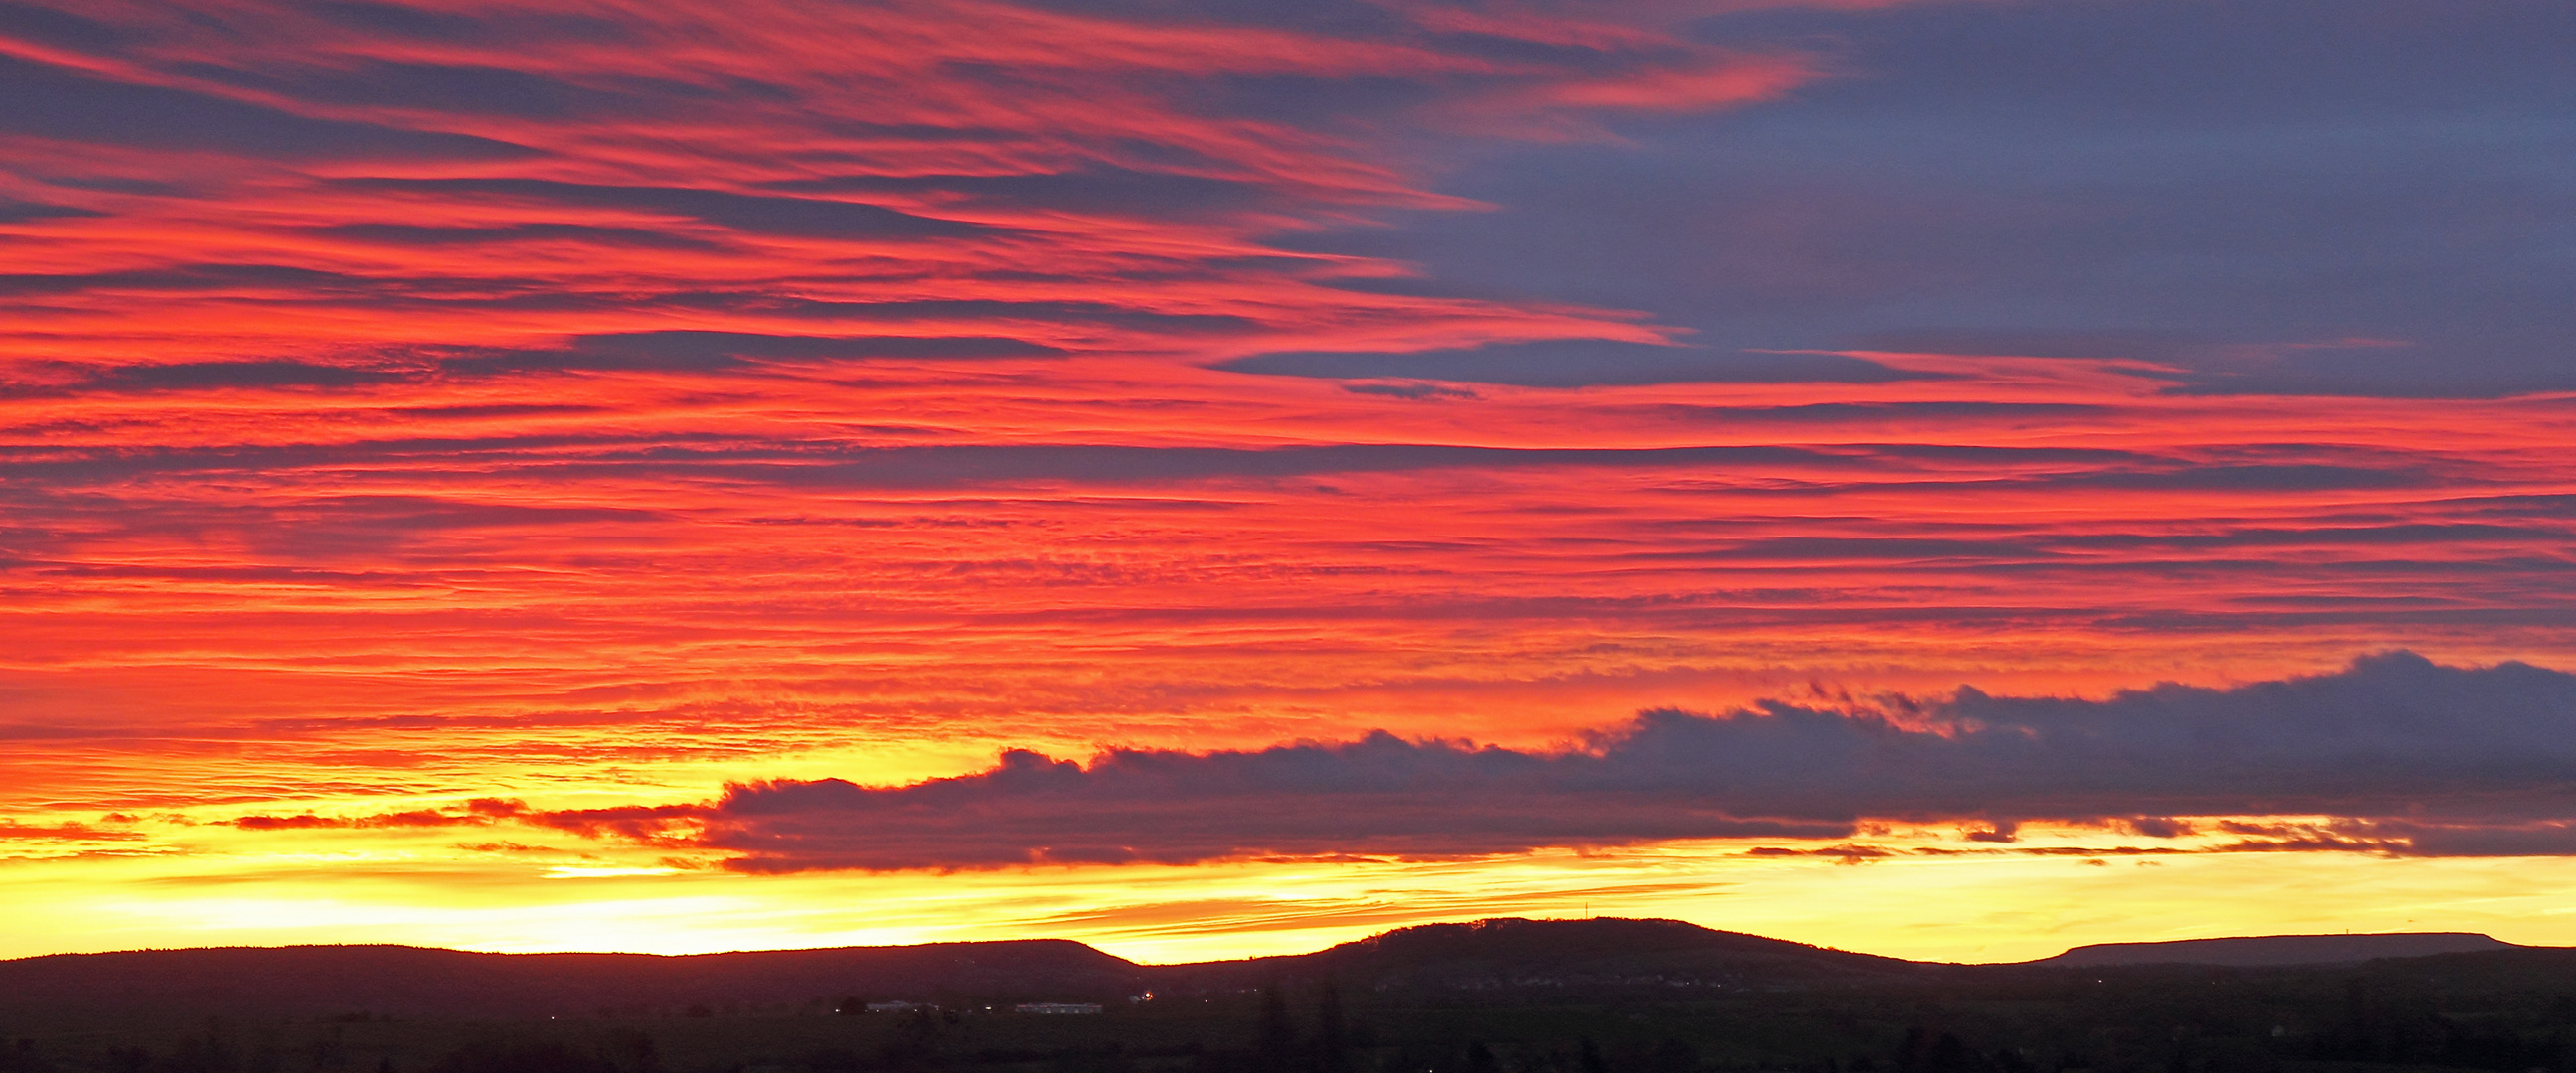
[0,939,1141,1019]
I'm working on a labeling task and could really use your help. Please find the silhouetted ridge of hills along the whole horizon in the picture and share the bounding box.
[0,919,2553,1019]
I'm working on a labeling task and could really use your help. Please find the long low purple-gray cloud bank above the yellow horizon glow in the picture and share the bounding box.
[649,654,2576,872]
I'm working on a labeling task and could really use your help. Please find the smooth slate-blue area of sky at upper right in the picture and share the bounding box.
[1249,0,2576,396]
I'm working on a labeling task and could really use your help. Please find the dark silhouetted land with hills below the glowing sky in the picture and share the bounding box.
[0,921,2576,1073]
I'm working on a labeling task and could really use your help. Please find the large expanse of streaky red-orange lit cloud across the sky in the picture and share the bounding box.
[0,0,2571,867]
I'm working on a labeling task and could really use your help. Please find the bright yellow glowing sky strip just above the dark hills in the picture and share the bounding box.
[0,832,2576,963]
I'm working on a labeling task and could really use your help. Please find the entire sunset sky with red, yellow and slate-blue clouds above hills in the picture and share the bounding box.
[0,0,2576,960]
